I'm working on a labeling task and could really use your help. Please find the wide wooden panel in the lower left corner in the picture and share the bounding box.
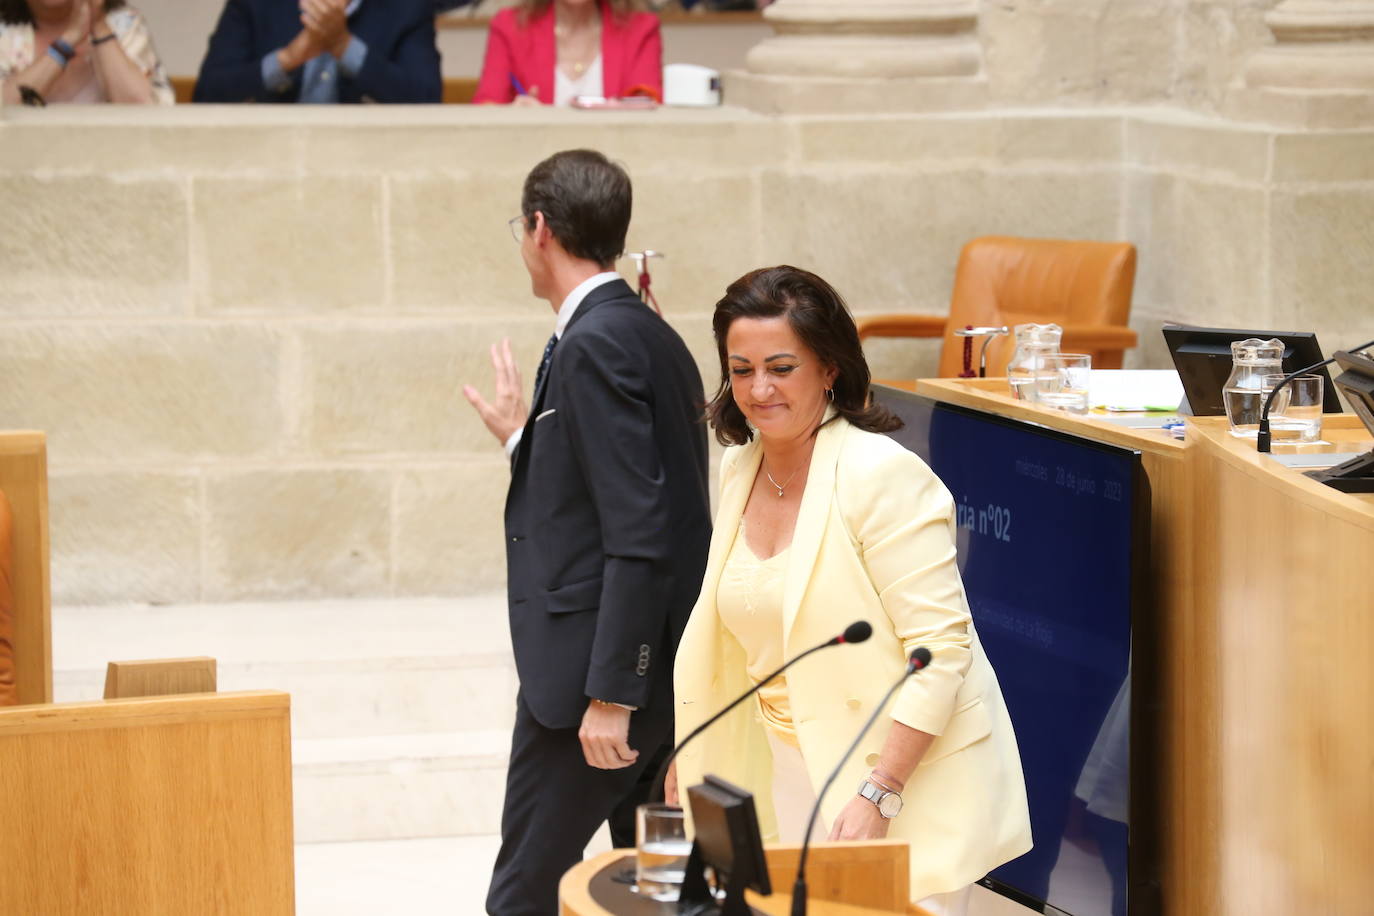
[0,692,295,916]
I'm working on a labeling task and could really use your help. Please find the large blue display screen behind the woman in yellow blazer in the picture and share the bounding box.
[878,389,1149,916]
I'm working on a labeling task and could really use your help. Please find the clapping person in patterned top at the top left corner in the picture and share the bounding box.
[0,0,174,104]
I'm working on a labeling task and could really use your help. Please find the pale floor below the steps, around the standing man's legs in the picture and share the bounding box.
[295,831,1033,916]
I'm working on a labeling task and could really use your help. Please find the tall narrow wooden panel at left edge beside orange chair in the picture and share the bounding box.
[0,431,52,703]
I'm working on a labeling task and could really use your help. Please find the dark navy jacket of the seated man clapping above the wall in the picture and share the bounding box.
[194,0,444,102]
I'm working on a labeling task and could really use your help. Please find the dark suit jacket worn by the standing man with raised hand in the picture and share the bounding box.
[506,280,710,728]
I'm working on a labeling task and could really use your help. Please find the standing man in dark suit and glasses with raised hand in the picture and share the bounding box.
[463,150,710,916]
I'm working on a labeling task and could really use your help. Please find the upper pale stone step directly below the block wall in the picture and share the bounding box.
[54,595,517,739]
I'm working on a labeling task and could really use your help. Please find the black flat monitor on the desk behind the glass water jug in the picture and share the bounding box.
[1164,324,1341,416]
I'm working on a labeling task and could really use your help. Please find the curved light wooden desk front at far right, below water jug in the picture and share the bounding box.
[1187,416,1374,913]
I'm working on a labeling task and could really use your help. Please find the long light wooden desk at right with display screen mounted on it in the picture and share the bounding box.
[904,379,1374,916]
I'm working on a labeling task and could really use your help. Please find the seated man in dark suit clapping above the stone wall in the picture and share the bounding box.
[194,0,444,103]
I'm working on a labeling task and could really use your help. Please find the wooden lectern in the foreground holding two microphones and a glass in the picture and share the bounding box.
[558,839,929,916]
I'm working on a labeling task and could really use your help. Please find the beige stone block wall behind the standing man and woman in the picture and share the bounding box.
[0,107,1374,603]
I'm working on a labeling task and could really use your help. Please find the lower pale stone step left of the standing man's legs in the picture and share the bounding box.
[291,729,510,843]
